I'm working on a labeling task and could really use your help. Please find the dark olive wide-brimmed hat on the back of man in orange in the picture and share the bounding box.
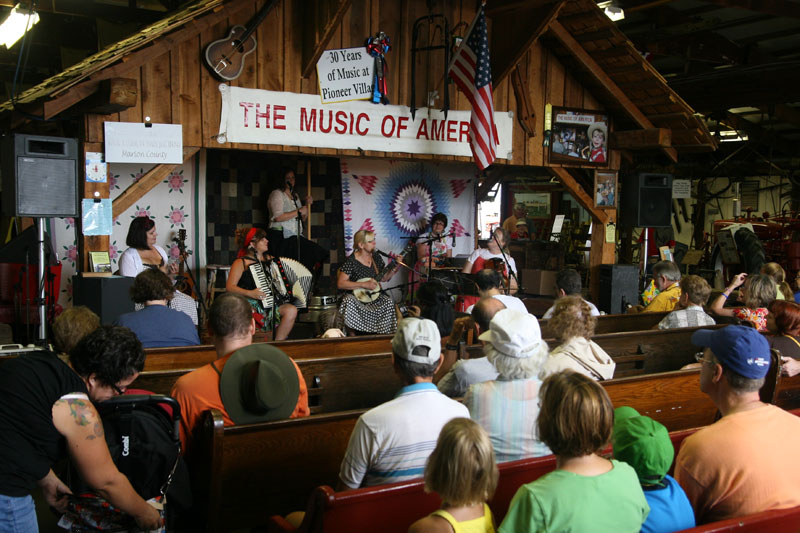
[219,343,300,424]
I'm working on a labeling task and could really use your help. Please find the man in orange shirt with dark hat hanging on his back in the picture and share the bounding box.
[172,292,309,451]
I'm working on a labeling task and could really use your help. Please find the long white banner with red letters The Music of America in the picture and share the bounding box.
[217,84,514,159]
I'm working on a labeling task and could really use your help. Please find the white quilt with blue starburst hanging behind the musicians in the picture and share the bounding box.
[341,158,476,300]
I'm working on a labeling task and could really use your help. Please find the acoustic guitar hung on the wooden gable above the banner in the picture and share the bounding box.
[205,0,278,81]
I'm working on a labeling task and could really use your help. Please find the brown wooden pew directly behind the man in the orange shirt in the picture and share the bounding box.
[190,370,716,531]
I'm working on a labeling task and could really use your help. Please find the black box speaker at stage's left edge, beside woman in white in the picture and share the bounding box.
[72,274,135,326]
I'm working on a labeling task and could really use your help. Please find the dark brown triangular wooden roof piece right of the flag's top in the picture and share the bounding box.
[487,0,566,87]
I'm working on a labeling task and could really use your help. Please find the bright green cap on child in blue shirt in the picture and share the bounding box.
[612,407,675,485]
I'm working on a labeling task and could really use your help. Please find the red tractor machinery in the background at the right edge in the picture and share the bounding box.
[711,213,800,288]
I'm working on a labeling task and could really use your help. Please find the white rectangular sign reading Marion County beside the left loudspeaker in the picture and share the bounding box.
[103,122,183,165]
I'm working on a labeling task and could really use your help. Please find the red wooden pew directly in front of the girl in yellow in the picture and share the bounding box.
[269,422,696,533]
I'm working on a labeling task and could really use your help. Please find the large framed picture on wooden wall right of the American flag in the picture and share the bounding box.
[550,107,609,167]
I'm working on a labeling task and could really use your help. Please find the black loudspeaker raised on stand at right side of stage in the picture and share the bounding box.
[620,174,672,228]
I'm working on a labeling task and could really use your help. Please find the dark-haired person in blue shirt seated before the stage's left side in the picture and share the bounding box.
[116,270,200,348]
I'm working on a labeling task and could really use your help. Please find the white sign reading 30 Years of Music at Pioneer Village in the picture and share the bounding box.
[317,46,375,104]
